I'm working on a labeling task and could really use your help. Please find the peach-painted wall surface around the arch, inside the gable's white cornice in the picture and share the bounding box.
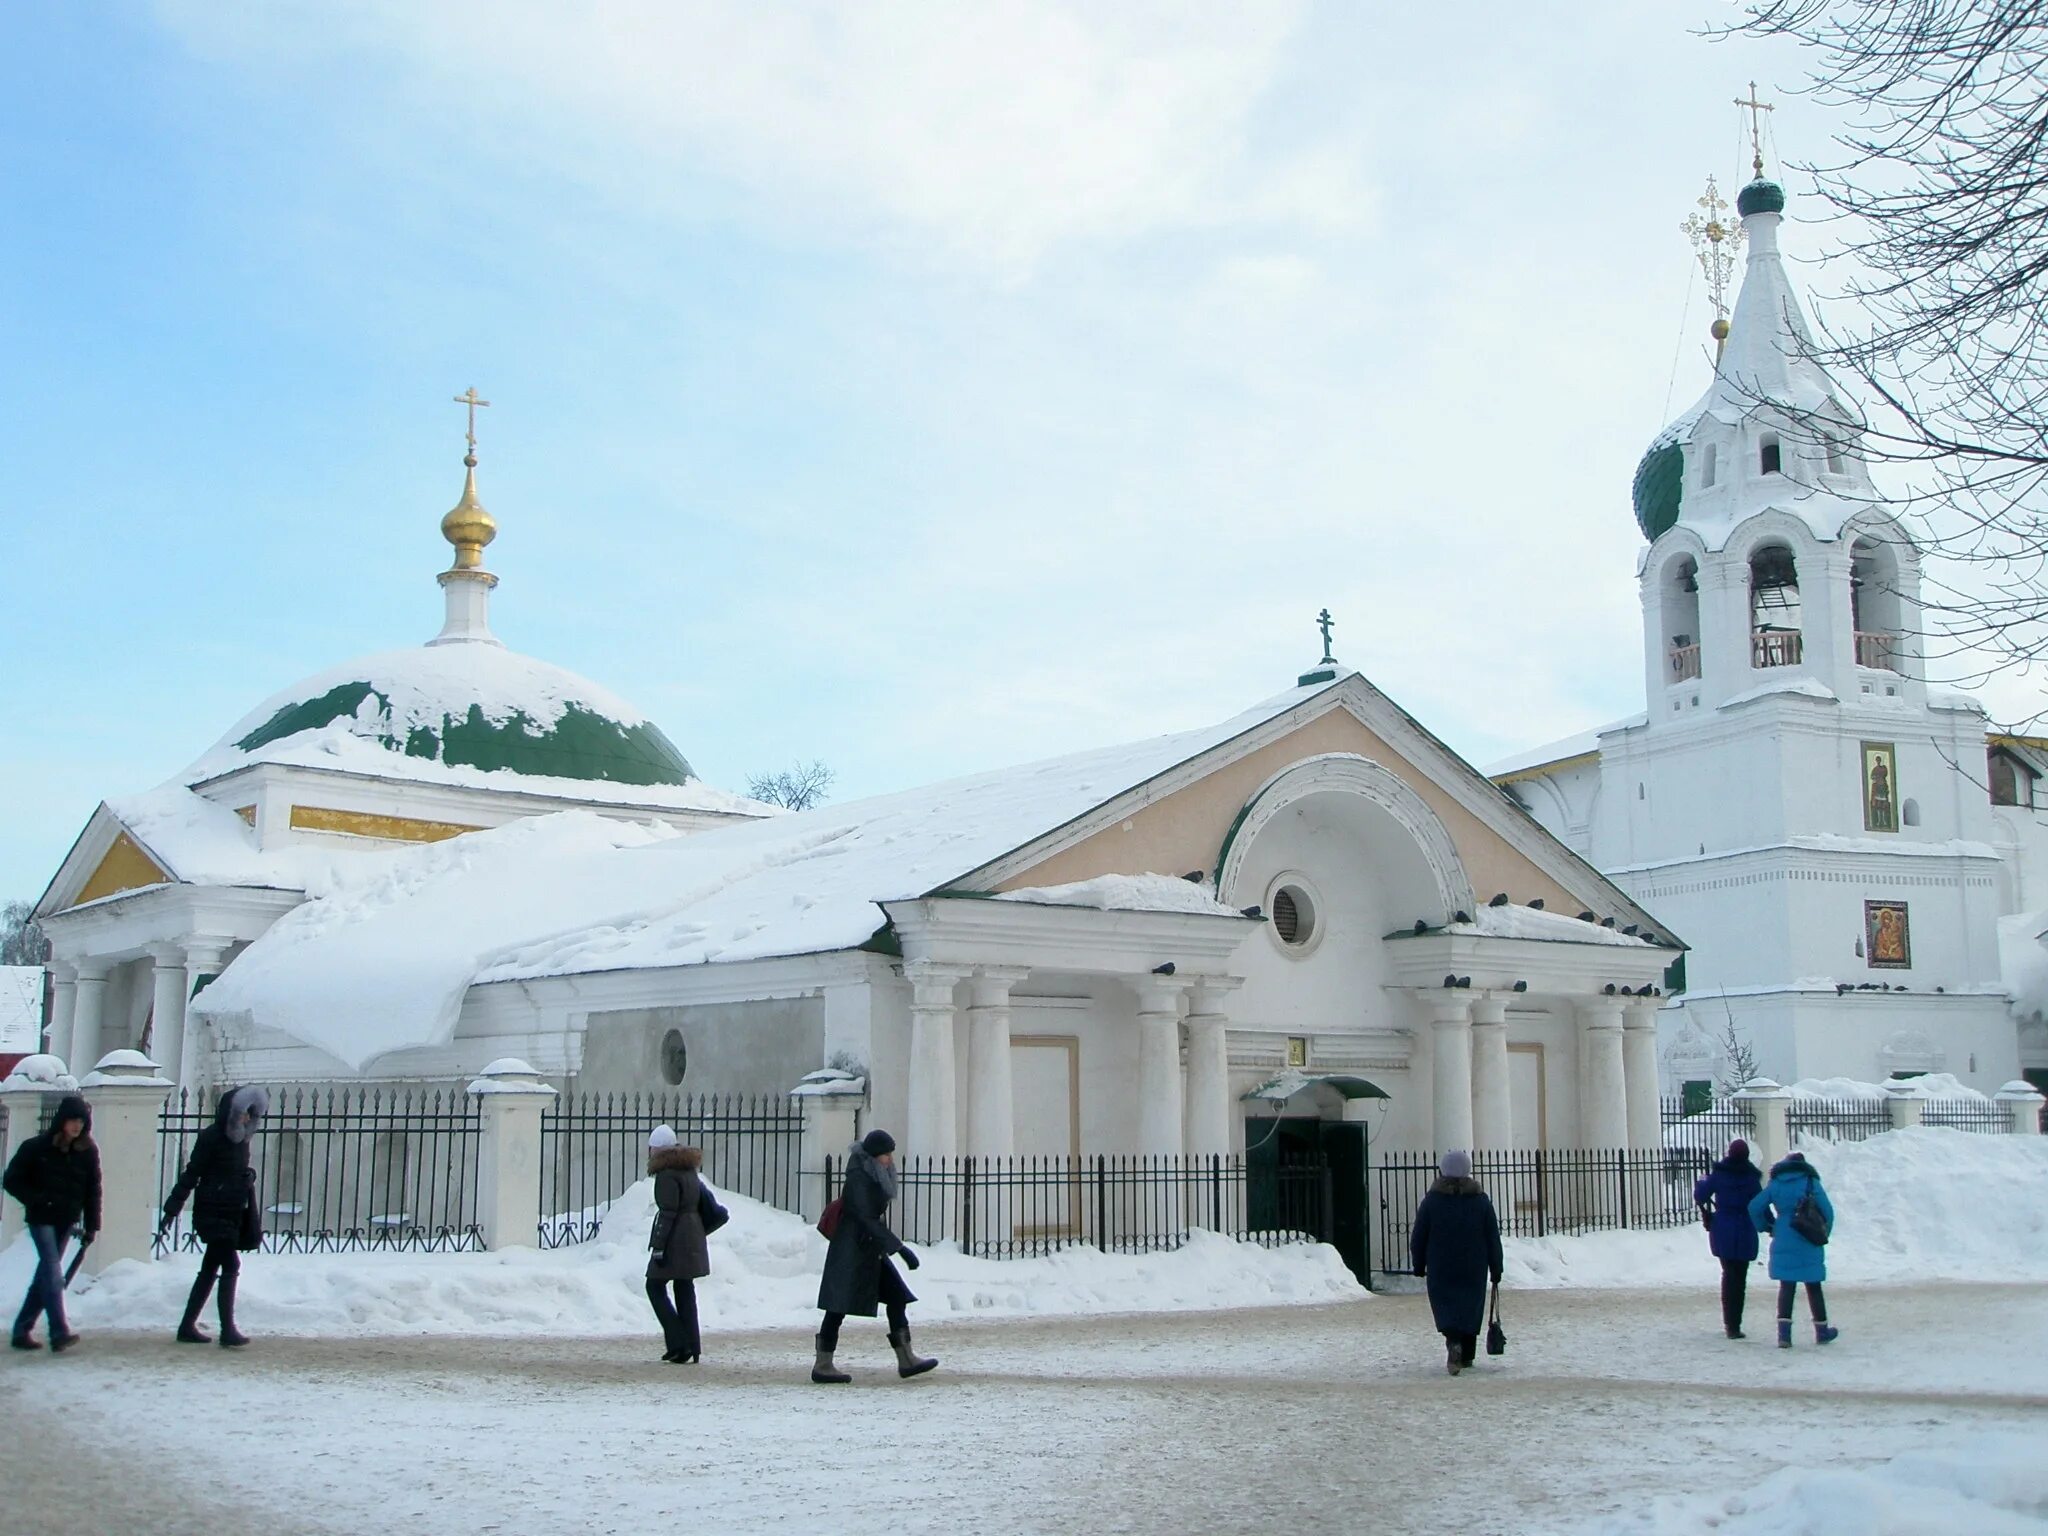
[995,709,1581,925]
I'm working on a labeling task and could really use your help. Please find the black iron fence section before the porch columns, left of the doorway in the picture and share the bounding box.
[825,1155,1333,1260]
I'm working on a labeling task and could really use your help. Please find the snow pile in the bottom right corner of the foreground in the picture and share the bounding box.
[1583,1430,2048,1536]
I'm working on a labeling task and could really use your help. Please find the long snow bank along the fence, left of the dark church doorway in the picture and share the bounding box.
[12,1180,1364,1335]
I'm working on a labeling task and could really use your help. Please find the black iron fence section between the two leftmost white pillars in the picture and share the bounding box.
[156,1087,483,1253]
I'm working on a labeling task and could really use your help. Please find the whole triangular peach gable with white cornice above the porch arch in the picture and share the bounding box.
[956,674,1667,936]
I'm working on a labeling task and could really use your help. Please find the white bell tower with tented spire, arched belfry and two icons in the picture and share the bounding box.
[1489,172,2048,1092]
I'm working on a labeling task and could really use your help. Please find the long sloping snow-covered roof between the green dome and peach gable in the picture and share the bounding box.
[193,674,1350,1067]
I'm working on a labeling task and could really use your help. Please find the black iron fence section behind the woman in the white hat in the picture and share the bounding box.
[539,1094,803,1247]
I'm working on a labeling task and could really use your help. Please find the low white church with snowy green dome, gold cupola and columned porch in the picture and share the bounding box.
[37,434,1679,1179]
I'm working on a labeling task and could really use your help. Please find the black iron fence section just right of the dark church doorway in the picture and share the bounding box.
[1372,1147,1718,1274]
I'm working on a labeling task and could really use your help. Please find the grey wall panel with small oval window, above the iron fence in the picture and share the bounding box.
[571,997,825,1094]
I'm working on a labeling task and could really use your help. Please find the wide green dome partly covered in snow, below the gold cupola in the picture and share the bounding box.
[203,645,694,784]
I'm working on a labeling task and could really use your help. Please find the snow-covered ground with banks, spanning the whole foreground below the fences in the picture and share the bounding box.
[0,1130,2048,1536]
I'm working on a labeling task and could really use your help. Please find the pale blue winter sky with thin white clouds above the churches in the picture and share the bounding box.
[0,0,1957,897]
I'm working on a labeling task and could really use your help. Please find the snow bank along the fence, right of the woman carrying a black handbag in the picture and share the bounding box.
[1505,1126,2048,1288]
